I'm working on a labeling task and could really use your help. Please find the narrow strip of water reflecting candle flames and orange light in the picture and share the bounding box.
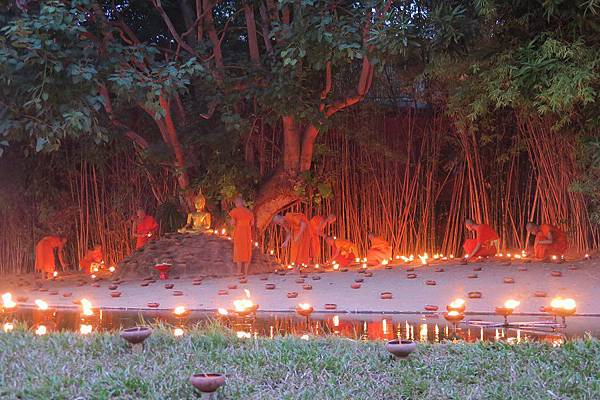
[0,309,600,346]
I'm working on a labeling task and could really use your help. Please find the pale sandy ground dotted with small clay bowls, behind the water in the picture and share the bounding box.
[0,259,600,316]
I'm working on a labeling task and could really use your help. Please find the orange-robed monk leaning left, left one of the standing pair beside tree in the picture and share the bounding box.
[273,213,310,267]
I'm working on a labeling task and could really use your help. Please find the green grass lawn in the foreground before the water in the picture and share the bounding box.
[0,326,600,400]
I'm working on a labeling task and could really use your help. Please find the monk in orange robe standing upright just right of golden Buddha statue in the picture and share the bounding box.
[229,197,254,275]
